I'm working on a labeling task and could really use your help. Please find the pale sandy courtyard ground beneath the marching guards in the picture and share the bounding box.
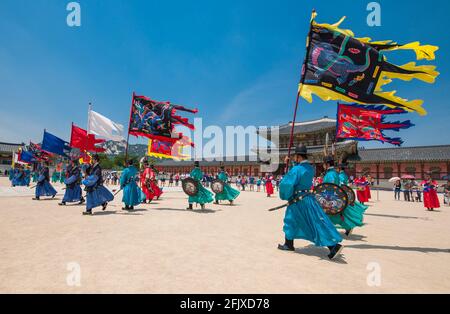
[0,178,450,293]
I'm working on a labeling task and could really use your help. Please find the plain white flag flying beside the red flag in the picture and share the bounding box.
[89,110,125,142]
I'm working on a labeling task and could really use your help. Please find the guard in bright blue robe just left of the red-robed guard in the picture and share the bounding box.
[120,160,143,210]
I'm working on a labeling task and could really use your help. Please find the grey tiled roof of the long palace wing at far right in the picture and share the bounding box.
[349,145,450,163]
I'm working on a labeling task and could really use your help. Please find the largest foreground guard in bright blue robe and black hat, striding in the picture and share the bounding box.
[278,145,343,259]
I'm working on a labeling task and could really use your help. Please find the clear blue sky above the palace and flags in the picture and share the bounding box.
[0,0,450,147]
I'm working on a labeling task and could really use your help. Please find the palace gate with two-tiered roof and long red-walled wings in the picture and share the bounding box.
[157,117,450,184]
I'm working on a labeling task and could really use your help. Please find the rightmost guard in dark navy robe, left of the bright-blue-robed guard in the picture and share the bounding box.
[82,155,114,215]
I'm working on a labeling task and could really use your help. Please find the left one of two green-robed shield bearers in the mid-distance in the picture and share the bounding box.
[183,161,214,210]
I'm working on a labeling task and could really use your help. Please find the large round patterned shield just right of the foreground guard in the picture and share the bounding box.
[314,183,348,216]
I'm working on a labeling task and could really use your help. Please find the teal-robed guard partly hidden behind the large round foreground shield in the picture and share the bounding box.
[323,156,367,236]
